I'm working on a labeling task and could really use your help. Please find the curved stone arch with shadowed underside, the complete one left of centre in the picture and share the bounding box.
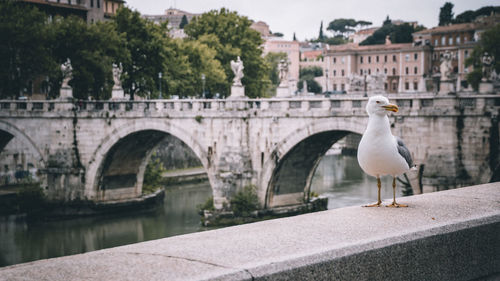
[85,120,215,200]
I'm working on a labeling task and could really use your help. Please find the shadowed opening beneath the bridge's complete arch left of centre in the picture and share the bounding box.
[93,129,211,203]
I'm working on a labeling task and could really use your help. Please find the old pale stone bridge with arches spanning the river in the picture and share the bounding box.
[0,93,500,208]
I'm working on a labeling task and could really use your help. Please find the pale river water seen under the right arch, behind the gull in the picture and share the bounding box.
[311,155,401,209]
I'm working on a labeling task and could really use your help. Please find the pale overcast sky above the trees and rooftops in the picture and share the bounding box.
[126,0,500,40]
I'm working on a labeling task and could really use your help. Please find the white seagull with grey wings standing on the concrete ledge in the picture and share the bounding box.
[358,96,413,207]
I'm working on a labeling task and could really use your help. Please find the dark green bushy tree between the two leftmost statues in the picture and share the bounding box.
[52,17,128,100]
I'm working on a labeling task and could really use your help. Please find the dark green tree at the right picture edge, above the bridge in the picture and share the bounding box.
[465,24,500,90]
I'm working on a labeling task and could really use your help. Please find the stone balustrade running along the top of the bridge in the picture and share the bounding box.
[0,94,500,116]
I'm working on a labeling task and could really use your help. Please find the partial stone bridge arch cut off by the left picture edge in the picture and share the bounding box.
[0,120,46,168]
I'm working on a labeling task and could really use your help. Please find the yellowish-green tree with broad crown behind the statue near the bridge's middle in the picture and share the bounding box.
[185,8,270,97]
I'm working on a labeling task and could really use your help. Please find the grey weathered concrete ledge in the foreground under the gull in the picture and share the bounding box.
[0,183,500,280]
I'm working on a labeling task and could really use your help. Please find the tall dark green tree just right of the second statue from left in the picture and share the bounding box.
[114,8,168,100]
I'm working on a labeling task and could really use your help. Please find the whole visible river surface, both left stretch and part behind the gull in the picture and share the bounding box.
[0,155,400,266]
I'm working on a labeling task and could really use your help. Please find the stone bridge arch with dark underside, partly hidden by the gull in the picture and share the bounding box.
[258,117,367,207]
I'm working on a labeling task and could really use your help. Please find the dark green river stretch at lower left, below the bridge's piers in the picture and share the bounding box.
[0,182,212,266]
